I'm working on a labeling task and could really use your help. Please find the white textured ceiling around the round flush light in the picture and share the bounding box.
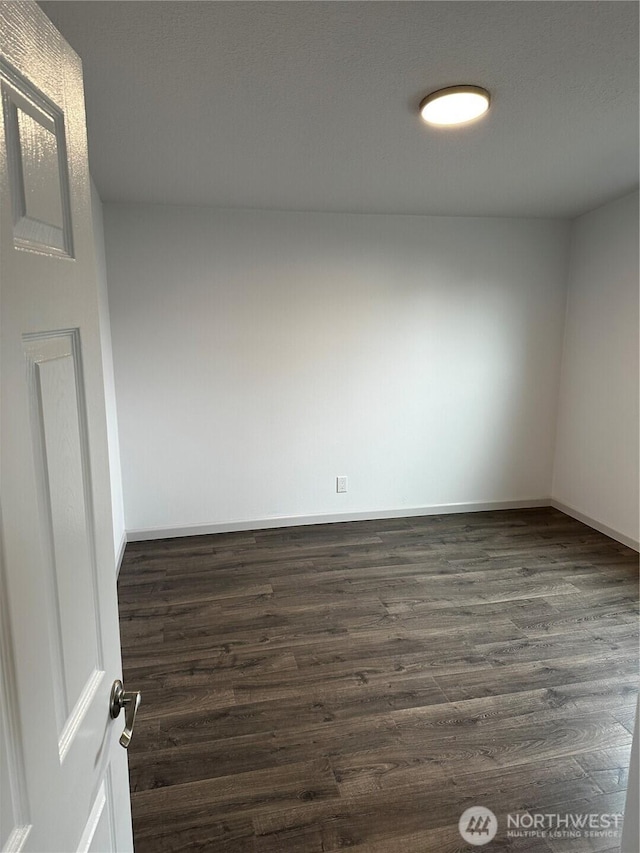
[41,0,638,217]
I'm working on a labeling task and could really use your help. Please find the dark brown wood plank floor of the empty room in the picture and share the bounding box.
[119,509,638,853]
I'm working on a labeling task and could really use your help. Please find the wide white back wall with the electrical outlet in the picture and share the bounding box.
[105,205,568,536]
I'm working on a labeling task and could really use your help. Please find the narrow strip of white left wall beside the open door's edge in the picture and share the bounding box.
[91,182,125,562]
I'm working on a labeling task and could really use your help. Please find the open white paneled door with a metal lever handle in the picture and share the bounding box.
[0,2,133,853]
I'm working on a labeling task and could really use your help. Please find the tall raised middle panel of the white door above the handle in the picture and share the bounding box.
[25,330,104,760]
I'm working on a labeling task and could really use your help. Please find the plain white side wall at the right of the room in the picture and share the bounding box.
[553,193,640,543]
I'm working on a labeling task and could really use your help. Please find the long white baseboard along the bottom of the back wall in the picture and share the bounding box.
[127,498,549,542]
